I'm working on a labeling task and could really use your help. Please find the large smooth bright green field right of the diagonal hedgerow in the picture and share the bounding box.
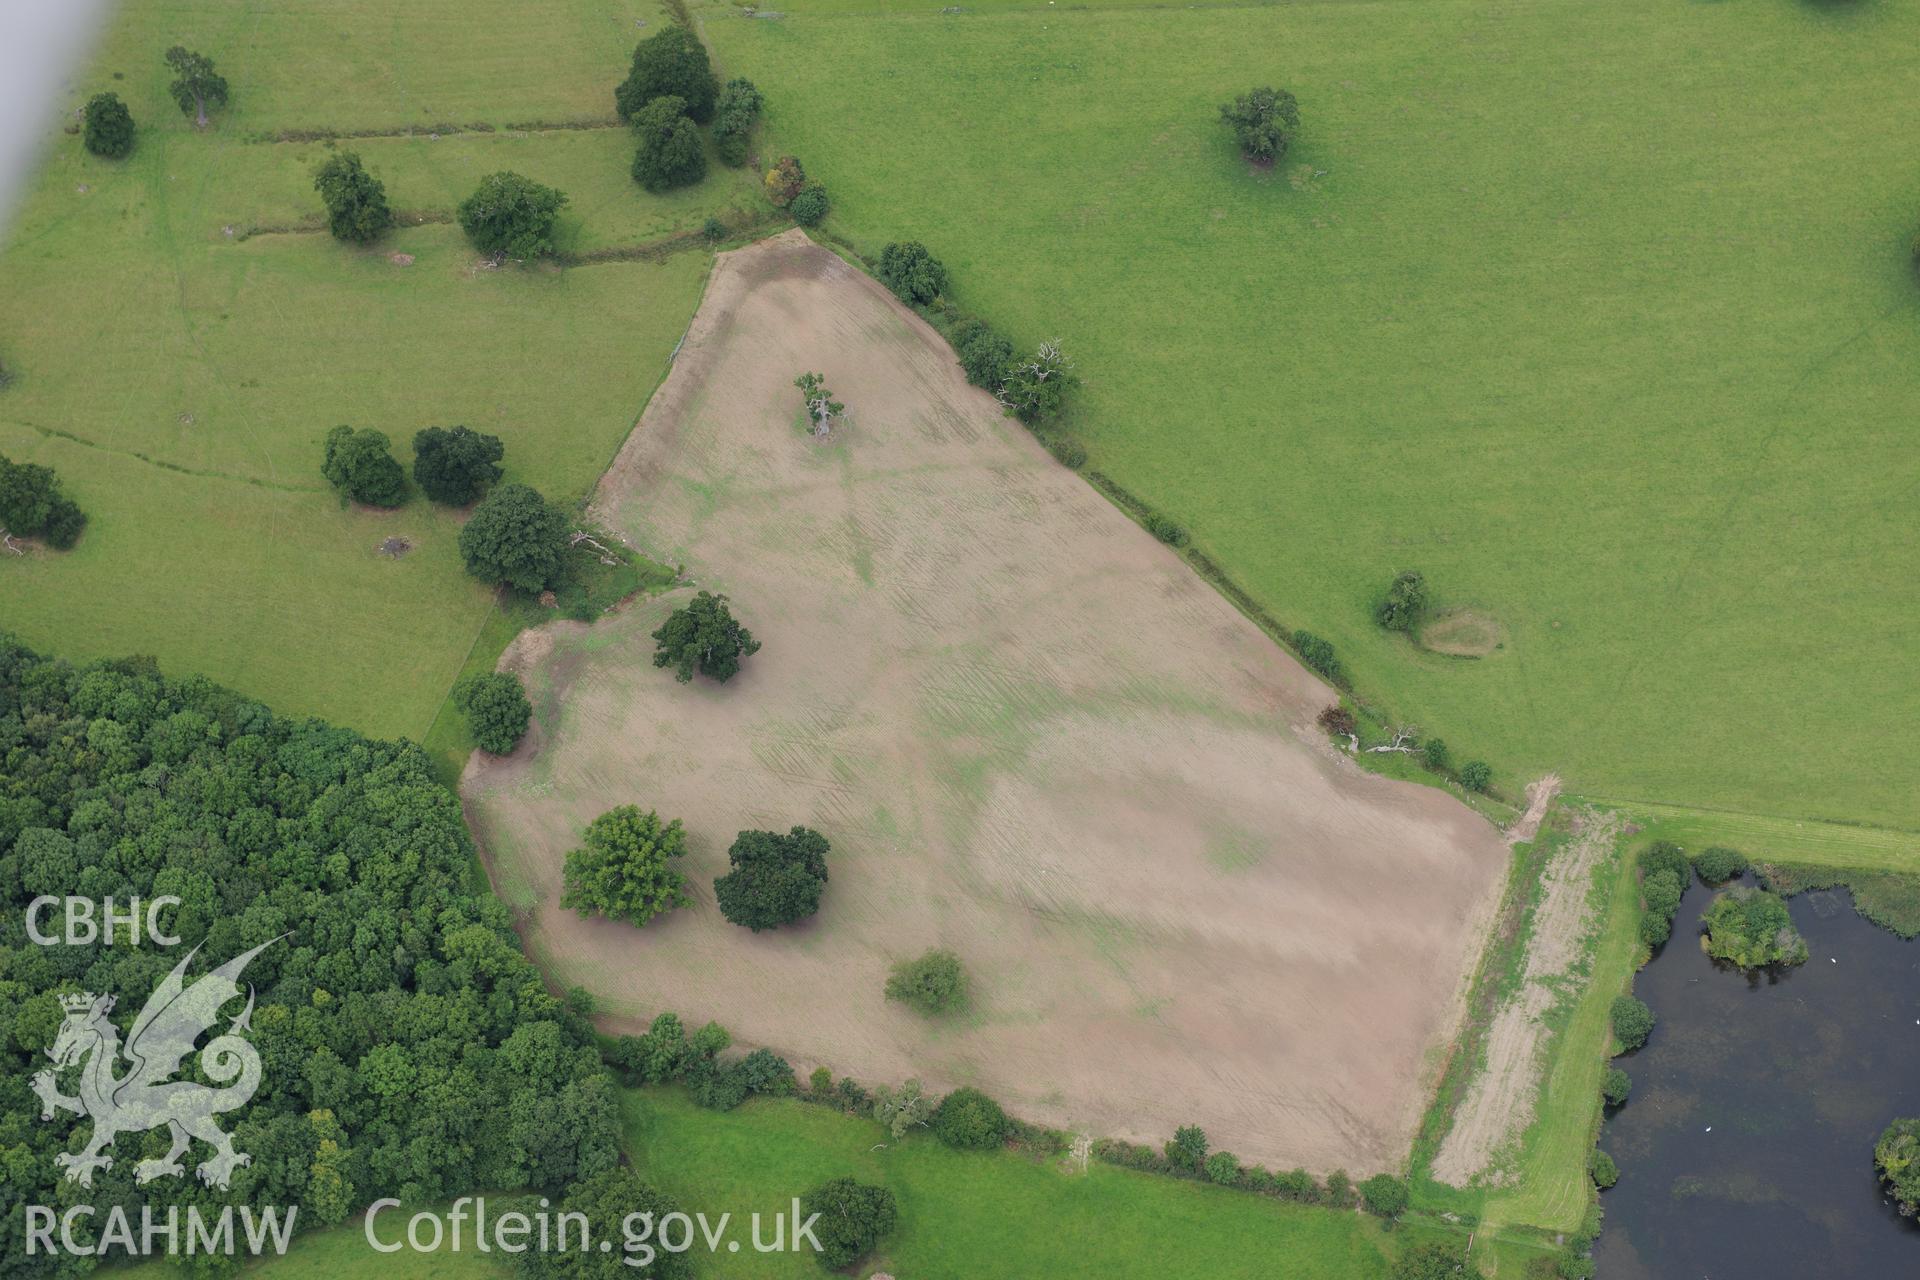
[697,0,1920,829]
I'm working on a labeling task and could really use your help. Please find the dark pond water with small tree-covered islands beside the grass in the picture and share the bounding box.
[1596,883,1920,1280]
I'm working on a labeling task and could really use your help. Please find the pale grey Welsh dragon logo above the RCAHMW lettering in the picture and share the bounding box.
[33,935,284,1190]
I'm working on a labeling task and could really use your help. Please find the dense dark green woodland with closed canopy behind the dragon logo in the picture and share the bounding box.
[0,635,618,1274]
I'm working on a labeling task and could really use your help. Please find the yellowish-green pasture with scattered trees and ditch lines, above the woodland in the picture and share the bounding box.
[0,0,758,737]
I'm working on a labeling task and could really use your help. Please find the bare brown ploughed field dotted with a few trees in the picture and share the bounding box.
[465,232,1507,1173]
